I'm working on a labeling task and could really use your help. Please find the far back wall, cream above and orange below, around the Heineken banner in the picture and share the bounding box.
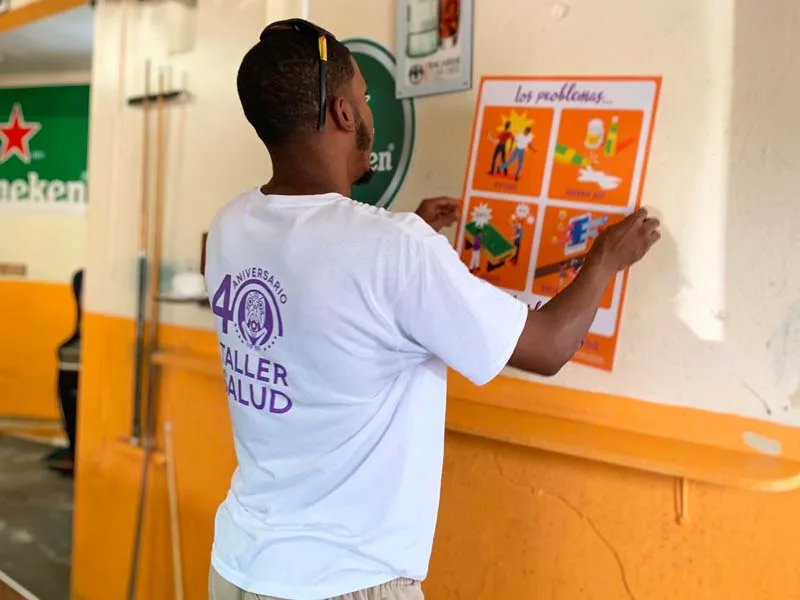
[0,72,90,419]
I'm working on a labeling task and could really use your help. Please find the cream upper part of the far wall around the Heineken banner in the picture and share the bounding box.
[0,72,91,283]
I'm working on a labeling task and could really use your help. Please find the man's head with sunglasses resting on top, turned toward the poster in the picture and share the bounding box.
[236,19,374,183]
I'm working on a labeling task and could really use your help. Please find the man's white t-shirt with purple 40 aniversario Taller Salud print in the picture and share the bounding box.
[206,190,527,600]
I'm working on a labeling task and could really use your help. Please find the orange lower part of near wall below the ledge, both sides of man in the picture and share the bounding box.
[72,315,800,600]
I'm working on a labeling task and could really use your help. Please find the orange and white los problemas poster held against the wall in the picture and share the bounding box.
[456,77,661,371]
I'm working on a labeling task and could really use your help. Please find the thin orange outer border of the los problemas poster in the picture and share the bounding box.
[454,75,663,372]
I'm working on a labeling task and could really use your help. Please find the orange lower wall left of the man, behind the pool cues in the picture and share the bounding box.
[72,314,236,600]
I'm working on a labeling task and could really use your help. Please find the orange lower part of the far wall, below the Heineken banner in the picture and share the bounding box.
[0,280,76,419]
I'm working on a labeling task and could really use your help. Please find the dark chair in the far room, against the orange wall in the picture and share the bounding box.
[47,270,83,473]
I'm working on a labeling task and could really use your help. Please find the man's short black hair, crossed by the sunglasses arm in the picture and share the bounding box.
[236,22,355,147]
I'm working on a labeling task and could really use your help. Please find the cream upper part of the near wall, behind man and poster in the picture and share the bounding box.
[88,0,800,420]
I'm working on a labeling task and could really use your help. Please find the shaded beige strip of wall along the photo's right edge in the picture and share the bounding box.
[726,0,800,412]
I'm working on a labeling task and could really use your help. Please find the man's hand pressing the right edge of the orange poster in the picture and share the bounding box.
[585,208,661,277]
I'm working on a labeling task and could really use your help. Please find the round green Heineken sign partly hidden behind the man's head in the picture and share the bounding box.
[343,39,416,208]
